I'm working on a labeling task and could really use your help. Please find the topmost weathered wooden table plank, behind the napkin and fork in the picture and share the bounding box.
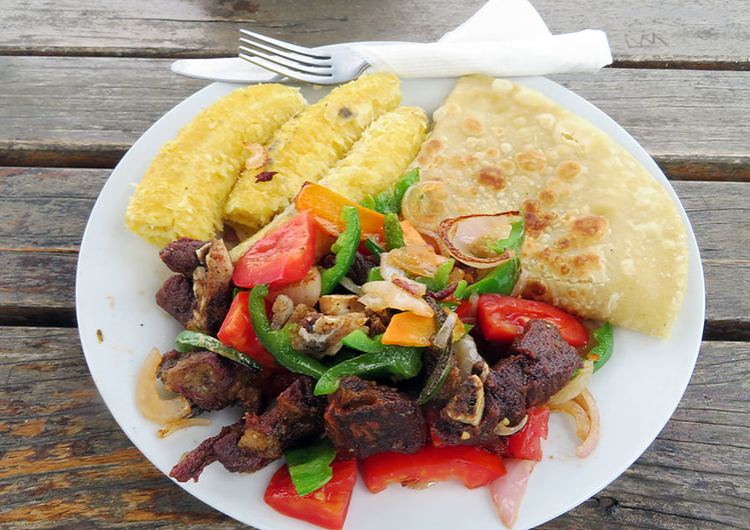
[0,0,750,69]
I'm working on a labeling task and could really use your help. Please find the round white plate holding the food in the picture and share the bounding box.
[76,77,705,530]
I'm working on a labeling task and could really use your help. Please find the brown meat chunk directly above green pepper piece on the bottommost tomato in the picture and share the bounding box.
[239,376,326,460]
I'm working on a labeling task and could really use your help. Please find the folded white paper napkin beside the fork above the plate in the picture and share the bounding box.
[352,0,612,78]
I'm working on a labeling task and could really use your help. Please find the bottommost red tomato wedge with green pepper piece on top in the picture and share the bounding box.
[263,459,357,530]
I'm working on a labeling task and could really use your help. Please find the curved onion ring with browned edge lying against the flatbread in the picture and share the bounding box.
[439,210,521,269]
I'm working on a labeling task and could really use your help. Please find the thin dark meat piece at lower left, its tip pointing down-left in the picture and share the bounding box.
[169,422,273,482]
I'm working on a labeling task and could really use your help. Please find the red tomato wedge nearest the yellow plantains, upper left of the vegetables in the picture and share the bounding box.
[232,208,316,289]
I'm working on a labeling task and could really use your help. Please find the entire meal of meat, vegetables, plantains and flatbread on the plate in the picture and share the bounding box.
[126,74,687,529]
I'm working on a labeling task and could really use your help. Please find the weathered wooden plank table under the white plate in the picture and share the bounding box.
[0,0,750,530]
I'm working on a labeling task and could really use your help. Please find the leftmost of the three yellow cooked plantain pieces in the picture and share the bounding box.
[125,84,307,247]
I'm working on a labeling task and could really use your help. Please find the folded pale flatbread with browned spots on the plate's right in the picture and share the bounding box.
[405,76,688,337]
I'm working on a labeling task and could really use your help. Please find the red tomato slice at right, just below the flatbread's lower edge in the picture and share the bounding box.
[477,294,589,347]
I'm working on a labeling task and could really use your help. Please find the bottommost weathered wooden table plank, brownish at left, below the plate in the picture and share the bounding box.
[0,328,750,530]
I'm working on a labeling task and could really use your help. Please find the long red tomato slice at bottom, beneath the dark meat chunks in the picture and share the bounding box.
[359,444,505,493]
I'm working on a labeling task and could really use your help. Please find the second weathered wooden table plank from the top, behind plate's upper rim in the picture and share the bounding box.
[0,57,750,176]
